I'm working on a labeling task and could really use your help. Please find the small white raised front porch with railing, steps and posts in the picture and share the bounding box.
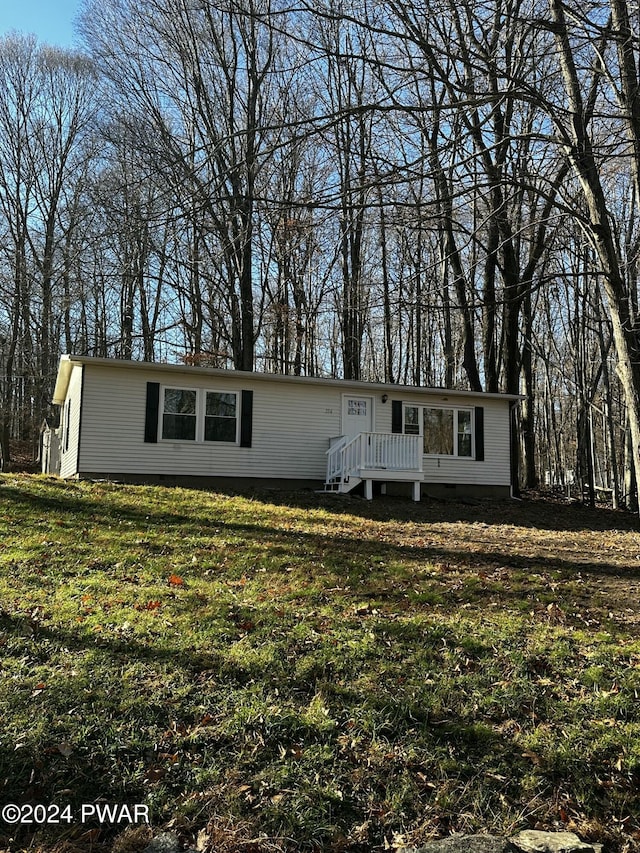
[324,432,424,501]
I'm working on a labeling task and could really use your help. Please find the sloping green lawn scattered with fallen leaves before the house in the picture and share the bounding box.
[0,475,640,853]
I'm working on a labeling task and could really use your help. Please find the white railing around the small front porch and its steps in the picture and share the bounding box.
[327,432,422,481]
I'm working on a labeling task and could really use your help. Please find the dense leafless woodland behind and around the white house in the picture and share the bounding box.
[0,0,640,508]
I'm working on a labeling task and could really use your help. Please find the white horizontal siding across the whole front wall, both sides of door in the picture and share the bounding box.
[75,362,510,486]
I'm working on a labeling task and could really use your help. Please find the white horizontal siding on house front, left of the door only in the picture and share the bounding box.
[81,364,341,480]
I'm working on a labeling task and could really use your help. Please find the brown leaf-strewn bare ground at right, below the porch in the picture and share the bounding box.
[278,486,640,627]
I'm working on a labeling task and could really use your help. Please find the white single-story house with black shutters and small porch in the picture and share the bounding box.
[43,355,519,500]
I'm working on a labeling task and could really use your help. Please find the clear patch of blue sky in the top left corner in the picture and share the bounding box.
[0,0,80,47]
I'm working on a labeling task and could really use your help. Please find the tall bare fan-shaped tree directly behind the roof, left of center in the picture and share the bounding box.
[83,0,290,370]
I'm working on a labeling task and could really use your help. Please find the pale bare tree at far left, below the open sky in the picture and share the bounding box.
[0,36,95,465]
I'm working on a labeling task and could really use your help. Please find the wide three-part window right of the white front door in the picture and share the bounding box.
[403,406,473,459]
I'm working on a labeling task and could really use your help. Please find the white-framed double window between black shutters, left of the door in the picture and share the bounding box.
[161,388,238,444]
